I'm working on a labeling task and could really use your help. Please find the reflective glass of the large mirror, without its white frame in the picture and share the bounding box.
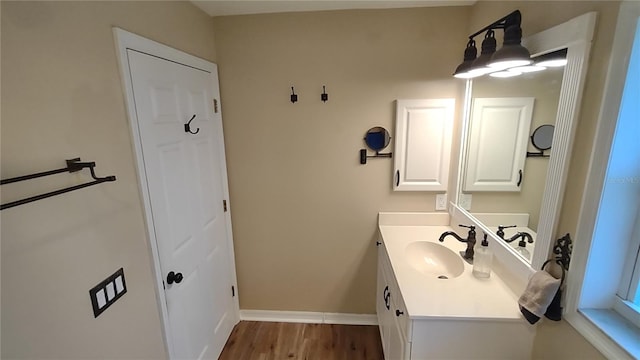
[459,65,564,262]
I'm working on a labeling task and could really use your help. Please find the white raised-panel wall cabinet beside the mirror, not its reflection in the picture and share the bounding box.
[393,99,455,192]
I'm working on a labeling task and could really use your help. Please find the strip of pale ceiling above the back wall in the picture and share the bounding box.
[191,0,476,16]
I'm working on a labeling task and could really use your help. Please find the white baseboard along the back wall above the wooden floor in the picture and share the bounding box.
[240,310,378,325]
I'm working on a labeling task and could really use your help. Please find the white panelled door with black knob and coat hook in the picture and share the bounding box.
[127,50,235,359]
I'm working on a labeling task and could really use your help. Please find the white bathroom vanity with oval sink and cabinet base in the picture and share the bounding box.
[376,213,535,360]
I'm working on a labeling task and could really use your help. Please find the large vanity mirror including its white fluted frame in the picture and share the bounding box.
[455,13,596,272]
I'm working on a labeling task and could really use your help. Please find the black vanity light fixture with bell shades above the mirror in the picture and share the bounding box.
[454,10,533,79]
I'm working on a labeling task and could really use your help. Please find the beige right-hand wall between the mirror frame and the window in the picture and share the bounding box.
[469,1,620,359]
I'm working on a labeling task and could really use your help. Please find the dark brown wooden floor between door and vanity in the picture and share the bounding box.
[219,321,384,360]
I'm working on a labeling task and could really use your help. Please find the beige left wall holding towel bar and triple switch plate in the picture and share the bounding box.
[1,1,216,359]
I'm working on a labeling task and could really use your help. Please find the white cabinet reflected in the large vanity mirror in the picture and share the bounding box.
[464,97,534,191]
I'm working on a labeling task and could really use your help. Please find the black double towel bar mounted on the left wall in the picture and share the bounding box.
[0,158,116,210]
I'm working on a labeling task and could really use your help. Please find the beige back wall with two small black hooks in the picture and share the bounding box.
[214,8,469,314]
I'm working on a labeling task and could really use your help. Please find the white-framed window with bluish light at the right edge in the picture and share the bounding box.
[566,1,640,359]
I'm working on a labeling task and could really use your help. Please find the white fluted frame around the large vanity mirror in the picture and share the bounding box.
[452,12,597,278]
